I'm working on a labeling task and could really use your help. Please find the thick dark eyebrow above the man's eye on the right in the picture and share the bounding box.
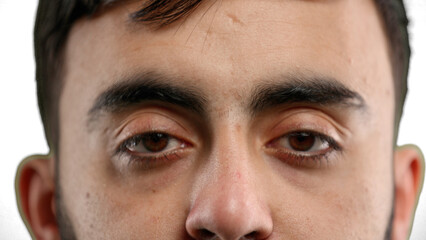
[250,77,367,115]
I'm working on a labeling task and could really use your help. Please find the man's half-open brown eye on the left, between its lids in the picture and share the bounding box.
[122,132,185,154]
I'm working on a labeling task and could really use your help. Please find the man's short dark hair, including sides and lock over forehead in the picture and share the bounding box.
[34,0,410,150]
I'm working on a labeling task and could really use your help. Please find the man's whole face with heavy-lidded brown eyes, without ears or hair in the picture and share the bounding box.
[59,0,394,240]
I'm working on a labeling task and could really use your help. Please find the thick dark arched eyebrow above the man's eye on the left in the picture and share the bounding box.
[88,72,206,125]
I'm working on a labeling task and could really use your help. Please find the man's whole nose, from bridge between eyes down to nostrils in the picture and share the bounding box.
[186,123,272,240]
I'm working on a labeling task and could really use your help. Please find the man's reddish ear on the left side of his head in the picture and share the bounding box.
[15,156,60,239]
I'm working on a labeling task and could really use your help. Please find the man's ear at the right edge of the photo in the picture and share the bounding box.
[392,145,424,240]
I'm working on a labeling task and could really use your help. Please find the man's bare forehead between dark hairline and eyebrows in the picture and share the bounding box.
[62,0,393,118]
